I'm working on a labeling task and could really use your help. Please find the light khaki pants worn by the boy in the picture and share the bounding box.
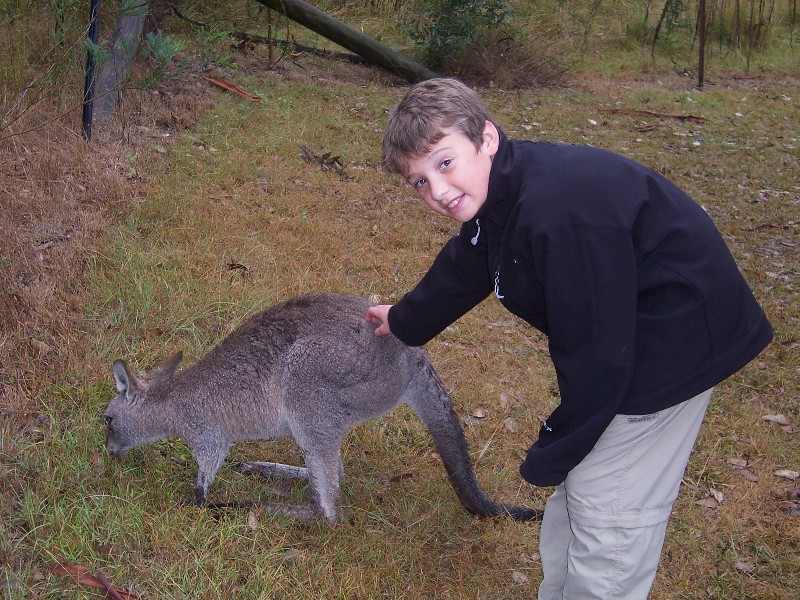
[539,390,712,600]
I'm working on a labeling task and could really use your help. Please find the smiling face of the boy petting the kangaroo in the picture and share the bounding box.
[406,121,500,223]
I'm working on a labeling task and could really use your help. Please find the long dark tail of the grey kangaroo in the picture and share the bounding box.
[407,353,542,521]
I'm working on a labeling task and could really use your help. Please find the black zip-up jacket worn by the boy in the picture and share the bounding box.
[389,133,772,486]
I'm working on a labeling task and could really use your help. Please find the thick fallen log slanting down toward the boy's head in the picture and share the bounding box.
[256,0,437,83]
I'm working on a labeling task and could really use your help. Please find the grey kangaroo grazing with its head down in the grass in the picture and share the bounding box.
[104,293,541,522]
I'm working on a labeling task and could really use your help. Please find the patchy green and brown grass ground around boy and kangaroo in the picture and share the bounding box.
[0,1,800,599]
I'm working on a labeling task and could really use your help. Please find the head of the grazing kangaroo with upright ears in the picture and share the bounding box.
[103,352,183,458]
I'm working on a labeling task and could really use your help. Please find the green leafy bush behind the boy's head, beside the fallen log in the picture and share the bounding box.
[405,0,514,69]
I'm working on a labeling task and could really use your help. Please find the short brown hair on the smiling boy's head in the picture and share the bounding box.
[381,78,494,175]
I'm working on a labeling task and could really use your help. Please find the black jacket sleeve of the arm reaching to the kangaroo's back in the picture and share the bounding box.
[389,221,493,346]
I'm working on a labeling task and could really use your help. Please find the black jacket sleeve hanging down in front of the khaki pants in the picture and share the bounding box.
[520,227,637,486]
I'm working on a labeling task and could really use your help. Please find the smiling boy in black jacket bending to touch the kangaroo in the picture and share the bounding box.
[367,79,772,600]
